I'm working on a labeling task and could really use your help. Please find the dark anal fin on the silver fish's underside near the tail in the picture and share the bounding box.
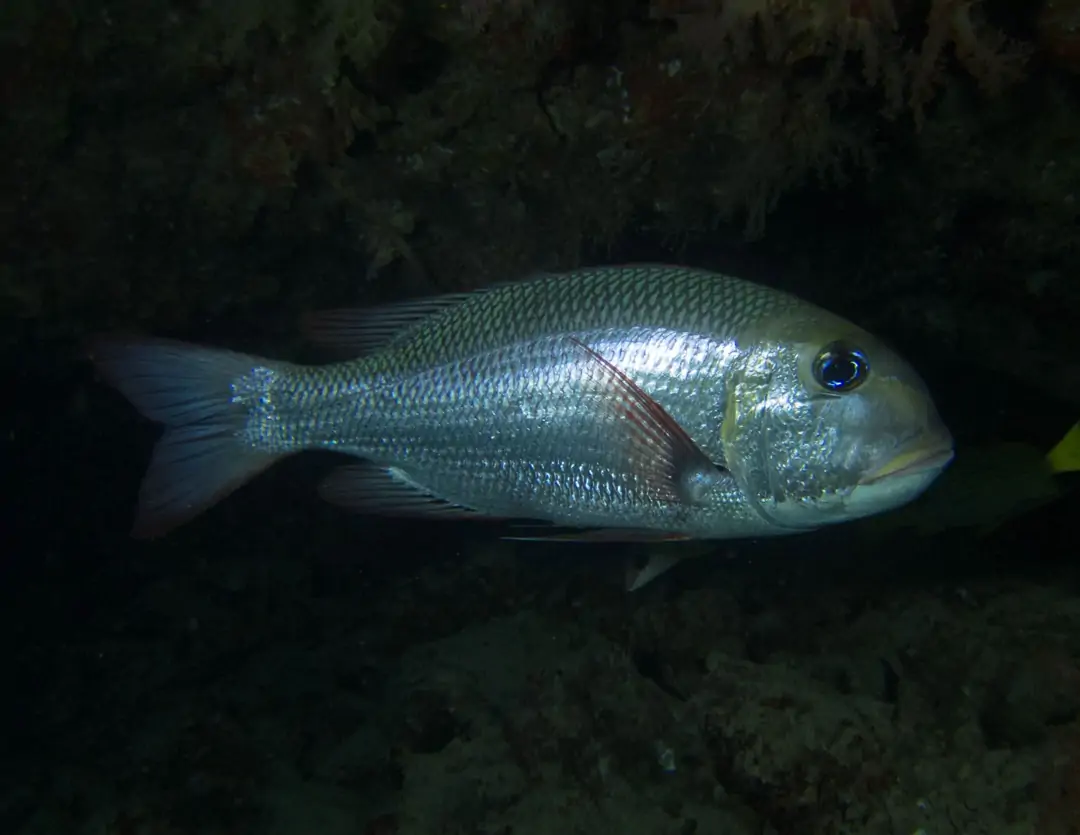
[319,463,494,520]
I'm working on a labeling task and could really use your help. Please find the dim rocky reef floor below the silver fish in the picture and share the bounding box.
[6,527,1080,835]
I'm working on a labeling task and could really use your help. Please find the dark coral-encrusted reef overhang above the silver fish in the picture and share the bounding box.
[6,0,1080,401]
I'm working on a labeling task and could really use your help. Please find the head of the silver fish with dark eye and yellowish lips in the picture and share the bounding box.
[723,309,953,528]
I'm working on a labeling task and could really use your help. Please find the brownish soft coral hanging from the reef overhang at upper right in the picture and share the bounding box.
[627,0,1026,231]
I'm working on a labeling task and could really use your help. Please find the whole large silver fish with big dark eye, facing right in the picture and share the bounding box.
[91,265,953,540]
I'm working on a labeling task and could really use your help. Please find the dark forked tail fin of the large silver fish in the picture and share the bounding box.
[90,338,279,539]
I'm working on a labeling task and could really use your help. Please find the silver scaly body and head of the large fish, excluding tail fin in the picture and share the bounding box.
[225,266,950,538]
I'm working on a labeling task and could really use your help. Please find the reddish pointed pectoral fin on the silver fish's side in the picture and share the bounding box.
[572,338,724,504]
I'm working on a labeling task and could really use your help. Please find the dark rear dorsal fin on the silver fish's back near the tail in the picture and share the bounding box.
[300,293,474,356]
